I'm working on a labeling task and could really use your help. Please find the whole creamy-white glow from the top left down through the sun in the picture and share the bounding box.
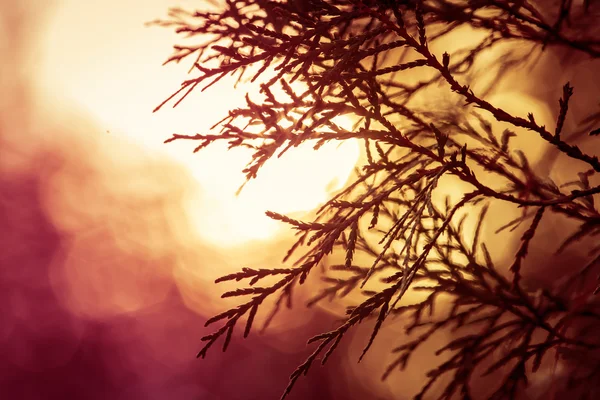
[40,0,359,246]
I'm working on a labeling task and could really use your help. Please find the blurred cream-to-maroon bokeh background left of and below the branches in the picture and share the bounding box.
[0,0,597,400]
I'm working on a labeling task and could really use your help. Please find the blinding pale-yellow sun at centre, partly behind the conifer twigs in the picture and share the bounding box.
[188,119,359,246]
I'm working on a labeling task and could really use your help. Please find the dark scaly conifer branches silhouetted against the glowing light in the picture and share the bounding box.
[155,0,600,399]
